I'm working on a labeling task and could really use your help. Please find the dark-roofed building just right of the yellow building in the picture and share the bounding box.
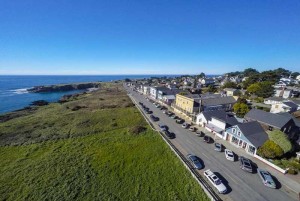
[200,96,236,111]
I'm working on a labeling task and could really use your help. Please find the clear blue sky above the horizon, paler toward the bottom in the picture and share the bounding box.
[0,0,300,74]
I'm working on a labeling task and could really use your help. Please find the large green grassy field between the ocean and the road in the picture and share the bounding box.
[0,85,208,200]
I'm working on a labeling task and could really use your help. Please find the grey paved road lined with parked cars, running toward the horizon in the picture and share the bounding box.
[127,88,298,201]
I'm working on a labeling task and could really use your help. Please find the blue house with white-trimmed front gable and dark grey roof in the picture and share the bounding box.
[224,121,269,155]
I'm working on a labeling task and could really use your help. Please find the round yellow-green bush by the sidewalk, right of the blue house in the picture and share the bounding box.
[257,140,284,159]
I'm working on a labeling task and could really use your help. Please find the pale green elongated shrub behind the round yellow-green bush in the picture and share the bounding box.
[268,129,293,153]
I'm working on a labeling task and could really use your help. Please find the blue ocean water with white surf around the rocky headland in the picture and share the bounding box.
[0,75,174,114]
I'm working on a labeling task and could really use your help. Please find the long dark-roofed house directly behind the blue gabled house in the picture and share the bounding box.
[244,109,297,139]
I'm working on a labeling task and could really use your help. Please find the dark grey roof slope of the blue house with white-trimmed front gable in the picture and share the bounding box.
[238,121,269,147]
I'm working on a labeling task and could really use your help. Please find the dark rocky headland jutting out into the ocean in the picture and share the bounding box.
[27,82,101,93]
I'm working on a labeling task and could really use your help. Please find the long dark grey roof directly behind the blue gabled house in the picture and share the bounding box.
[245,109,291,129]
